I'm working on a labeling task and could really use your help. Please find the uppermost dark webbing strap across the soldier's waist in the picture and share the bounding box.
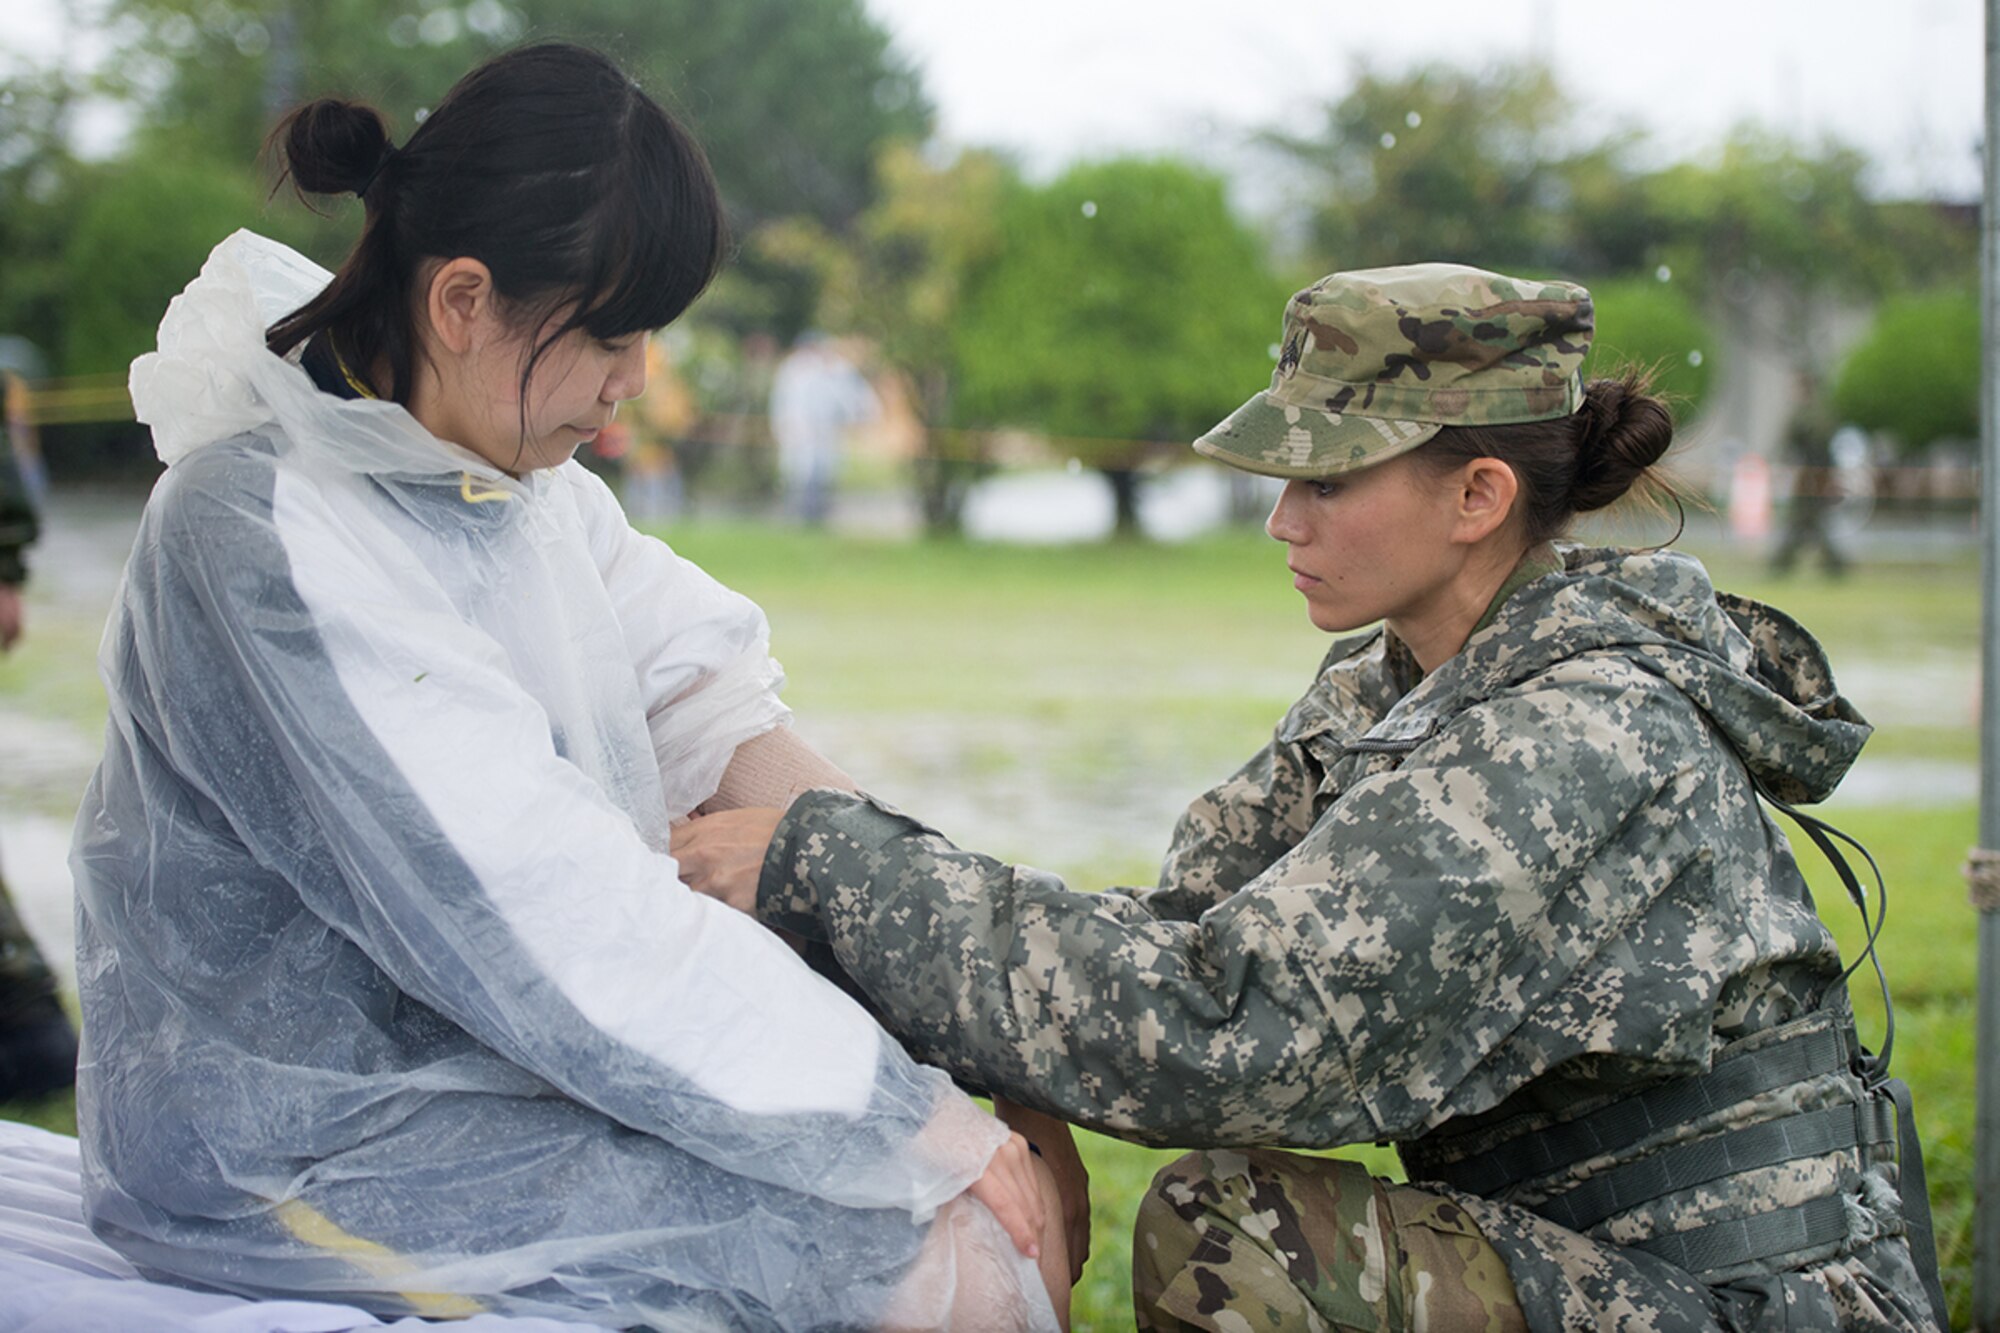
[1406,1023,1852,1197]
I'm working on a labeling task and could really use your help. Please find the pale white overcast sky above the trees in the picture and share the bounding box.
[11,0,1984,200]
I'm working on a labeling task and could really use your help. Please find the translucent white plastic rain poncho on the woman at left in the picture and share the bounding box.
[72,232,1054,1329]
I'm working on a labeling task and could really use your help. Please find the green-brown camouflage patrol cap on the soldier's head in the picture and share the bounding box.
[1194,264,1592,476]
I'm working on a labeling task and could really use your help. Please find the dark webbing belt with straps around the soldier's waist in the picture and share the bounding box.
[1398,793,1946,1329]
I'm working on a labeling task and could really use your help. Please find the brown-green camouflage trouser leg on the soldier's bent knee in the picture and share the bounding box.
[1132,1149,1528,1333]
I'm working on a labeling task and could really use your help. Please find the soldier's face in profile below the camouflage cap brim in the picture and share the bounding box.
[1264,454,1462,632]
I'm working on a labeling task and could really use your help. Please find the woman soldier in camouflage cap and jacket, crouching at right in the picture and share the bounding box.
[674,264,1942,1331]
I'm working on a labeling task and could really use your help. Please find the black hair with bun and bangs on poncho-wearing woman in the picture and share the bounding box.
[266,44,726,404]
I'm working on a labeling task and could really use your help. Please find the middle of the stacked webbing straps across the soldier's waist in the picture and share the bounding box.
[1530,1097,1896,1231]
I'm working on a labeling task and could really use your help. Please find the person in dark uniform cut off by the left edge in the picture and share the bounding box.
[0,374,76,1101]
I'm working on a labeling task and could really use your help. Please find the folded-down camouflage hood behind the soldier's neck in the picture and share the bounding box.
[1368,546,1870,803]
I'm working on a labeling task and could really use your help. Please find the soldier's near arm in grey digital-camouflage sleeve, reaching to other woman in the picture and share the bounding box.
[758,664,1718,1145]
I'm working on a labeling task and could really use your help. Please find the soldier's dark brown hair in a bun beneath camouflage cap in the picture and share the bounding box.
[1414,370,1680,542]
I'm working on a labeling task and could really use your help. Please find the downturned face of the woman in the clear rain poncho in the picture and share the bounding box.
[424,312,646,474]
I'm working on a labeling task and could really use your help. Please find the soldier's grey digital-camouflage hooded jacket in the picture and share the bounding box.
[758,550,1930,1329]
